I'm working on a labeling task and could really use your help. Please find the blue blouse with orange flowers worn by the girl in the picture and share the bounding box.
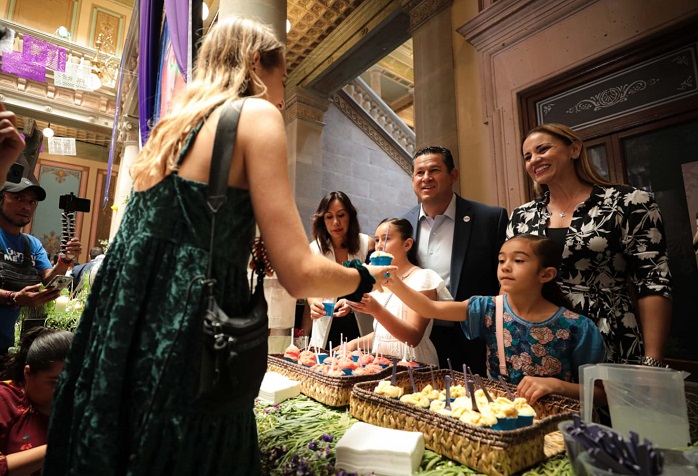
[461,296,606,384]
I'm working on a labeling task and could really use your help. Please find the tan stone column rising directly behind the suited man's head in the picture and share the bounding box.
[402,0,465,192]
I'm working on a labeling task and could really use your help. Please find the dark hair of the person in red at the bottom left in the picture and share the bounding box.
[0,327,73,385]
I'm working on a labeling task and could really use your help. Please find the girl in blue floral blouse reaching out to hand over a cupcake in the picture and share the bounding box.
[386,235,605,403]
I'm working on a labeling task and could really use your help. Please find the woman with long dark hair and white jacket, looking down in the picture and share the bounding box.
[308,191,375,348]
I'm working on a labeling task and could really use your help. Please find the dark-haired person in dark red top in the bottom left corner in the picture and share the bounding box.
[0,327,73,476]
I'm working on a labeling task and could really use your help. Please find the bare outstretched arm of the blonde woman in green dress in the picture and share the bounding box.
[238,98,386,297]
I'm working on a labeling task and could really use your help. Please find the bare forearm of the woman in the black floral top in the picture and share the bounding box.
[637,295,672,362]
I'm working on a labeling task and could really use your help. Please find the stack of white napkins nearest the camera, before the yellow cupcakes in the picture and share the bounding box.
[335,422,424,476]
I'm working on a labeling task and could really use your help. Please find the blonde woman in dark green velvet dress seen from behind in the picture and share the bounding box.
[44,18,388,476]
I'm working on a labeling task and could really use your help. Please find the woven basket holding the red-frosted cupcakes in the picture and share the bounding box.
[267,354,392,407]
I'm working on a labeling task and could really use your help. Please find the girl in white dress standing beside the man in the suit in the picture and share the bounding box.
[347,218,453,365]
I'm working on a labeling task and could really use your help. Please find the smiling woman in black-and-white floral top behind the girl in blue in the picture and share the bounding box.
[507,124,671,365]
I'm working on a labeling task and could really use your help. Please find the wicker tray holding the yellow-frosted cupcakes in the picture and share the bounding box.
[349,370,579,476]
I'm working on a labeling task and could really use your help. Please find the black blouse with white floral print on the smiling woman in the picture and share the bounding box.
[507,185,671,363]
